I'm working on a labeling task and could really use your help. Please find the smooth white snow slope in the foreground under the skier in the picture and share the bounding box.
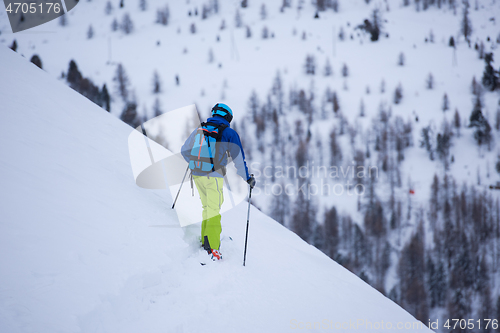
[0,47,434,333]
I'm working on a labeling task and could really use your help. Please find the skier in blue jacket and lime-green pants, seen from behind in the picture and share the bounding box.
[181,103,256,261]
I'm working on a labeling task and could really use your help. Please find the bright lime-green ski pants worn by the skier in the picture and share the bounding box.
[193,176,224,250]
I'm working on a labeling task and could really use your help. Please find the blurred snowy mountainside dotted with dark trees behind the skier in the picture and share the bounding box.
[0,0,500,326]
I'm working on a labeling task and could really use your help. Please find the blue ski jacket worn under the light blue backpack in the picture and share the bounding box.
[181,116,250,181]
